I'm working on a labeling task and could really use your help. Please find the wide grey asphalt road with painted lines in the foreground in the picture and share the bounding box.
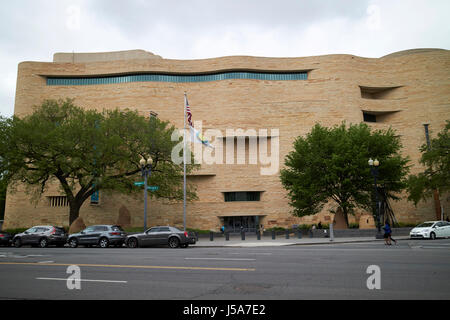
[0,239,450,301]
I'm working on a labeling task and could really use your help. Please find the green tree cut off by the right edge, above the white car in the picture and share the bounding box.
[407,120,450,209]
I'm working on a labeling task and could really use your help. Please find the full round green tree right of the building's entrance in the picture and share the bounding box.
[281,123,409,225]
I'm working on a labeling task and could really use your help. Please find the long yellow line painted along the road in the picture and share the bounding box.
[0,262,256,271]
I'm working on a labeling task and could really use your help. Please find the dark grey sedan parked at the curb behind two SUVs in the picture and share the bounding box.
[125,226,198,248]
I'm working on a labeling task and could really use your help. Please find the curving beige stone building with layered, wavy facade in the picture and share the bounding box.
[4,49,450,230]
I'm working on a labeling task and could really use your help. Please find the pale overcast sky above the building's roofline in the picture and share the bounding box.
[0,0,450,117]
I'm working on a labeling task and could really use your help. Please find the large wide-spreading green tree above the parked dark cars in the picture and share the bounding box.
[0,99,196,224]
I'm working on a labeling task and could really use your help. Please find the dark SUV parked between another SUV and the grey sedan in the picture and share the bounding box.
[67,225,127,248]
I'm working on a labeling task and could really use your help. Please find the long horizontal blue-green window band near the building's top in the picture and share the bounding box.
[47,72,308,86]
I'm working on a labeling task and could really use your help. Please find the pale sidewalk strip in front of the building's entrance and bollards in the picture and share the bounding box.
[191,236,409,248]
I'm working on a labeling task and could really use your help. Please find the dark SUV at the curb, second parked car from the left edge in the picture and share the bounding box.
[12,226,67,248]
